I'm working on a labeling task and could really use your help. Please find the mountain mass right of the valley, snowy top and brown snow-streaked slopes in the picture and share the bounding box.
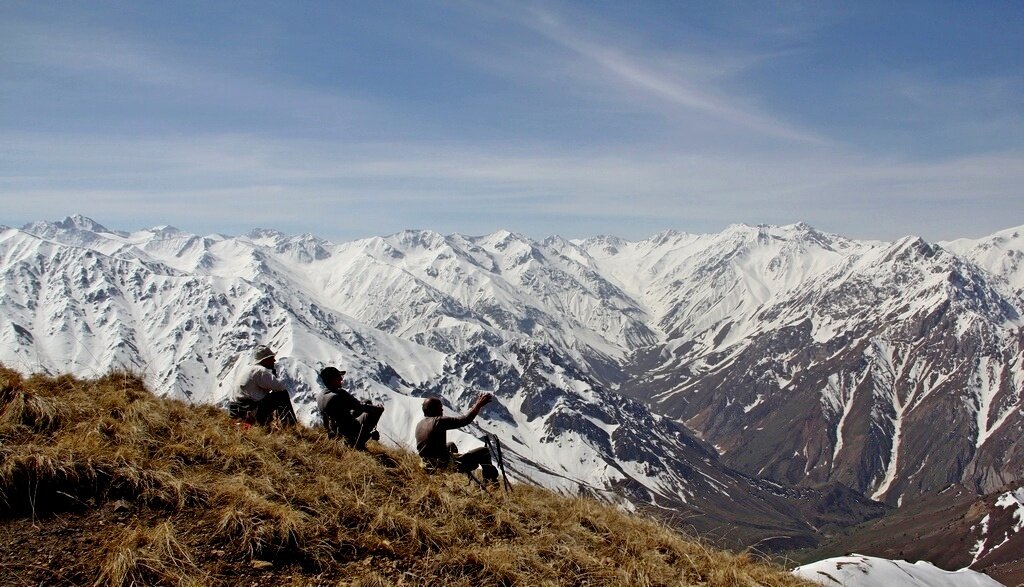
[583,225,1024,505]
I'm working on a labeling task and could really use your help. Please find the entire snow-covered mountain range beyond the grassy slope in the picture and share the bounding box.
[0,217,1024,546]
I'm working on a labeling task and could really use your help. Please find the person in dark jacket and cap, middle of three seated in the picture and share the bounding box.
[316,367,384,451]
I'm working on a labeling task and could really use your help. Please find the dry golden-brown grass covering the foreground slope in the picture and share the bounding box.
[0,368,805,586]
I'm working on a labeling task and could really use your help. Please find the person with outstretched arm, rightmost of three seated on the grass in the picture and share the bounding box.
[416,393,498,483]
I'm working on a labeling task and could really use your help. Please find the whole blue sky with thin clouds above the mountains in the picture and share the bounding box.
[0,0,1024,241]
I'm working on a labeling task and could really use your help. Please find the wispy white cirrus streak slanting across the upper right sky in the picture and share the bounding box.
[446,4,829,145]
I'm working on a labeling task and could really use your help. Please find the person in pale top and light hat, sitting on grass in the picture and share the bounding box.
[227,346,296,426]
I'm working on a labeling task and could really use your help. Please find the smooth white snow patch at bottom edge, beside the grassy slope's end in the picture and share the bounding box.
[793,554,1004,587]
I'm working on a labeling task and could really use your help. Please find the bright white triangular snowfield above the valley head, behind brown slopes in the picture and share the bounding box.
[579,224,870,347]
